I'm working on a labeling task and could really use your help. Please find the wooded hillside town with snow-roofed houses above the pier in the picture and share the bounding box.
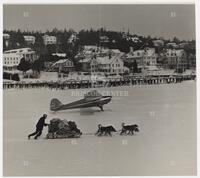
[3,28,196,88]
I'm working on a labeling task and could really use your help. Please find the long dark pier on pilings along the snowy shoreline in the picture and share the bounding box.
[3,75,196,90]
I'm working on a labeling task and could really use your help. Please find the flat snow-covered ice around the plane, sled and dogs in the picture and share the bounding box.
[3,81,197,176]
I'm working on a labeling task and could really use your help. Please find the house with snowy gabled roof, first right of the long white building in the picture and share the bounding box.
[51,59,74,72]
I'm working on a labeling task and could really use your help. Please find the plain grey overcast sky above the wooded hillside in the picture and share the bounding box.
[3,4,195,40]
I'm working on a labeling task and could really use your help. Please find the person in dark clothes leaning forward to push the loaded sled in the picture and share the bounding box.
[28,114,48,139]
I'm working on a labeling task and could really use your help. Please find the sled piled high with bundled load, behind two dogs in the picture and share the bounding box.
[46,118,82,139]
